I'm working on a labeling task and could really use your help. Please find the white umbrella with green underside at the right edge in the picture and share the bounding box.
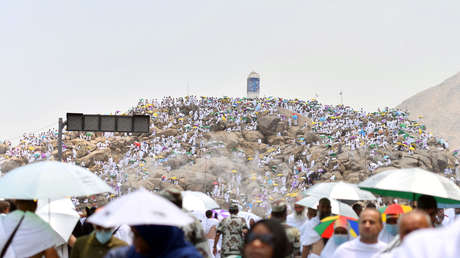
[358,168,460,204]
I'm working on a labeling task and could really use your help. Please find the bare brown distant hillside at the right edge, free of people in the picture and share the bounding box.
[398,73,460,150]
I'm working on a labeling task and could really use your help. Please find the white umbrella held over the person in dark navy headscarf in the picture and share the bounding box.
[88,188,193,227]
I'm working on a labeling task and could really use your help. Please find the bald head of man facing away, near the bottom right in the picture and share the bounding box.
[399,209,432,241]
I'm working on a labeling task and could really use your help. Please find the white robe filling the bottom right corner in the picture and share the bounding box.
[393,219,460,258]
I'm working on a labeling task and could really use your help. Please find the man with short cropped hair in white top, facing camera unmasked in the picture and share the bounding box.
[332,208,386,258]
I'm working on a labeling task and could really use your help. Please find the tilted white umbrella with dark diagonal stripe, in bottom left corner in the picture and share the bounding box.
[0,210,63,257]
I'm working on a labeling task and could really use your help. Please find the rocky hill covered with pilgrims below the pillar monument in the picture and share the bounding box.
[0,97,458,214]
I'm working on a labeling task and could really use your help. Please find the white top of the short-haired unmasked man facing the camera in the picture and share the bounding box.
[332,238,386,258]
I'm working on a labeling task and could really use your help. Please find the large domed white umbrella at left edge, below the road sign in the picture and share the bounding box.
[0,161,112,200]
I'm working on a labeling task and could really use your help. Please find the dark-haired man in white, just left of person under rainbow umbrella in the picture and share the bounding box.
[300,198,331,258]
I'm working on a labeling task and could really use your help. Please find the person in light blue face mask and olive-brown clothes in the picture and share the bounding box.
[70,225,128,258]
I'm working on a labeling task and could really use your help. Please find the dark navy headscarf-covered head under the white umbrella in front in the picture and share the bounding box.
[131,225,185,257]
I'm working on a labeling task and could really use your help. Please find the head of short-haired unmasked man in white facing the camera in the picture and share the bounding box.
[359,208,383,244]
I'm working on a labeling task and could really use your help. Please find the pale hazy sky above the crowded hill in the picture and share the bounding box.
[0,0,460,142]
